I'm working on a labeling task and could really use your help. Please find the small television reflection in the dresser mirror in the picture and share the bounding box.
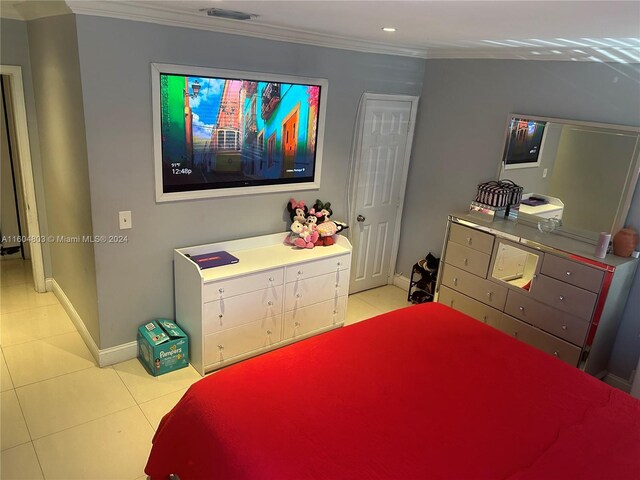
[504,117,547,168]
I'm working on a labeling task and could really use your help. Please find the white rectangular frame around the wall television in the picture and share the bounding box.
[151,63,329,202]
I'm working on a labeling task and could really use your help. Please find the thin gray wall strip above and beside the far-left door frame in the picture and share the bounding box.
[0,18,51,277]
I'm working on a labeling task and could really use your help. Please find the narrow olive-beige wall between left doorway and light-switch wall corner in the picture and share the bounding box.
[28,15,100,344]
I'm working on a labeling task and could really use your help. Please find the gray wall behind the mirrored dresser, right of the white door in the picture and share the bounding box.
[396,60,640,379]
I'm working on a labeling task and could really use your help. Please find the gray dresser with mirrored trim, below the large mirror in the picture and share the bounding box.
[436,214,637,376]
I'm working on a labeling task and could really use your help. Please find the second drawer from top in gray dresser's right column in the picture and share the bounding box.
[531,275,598,321]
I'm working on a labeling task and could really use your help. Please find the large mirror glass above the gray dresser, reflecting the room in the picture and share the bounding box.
[498,114,640,242]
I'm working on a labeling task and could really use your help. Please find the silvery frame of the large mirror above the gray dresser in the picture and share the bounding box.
[497,113,640,245]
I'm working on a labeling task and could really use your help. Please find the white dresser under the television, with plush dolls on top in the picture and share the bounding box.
[174,233,351,375]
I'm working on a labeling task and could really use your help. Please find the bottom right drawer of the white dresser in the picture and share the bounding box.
[283,295,347,340]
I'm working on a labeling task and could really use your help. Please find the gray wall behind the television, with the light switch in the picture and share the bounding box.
[77,16,425,349]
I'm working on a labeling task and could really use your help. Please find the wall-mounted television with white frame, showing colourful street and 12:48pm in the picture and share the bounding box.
[151,63,328,202]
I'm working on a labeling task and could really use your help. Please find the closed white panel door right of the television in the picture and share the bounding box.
[350,95,417,293]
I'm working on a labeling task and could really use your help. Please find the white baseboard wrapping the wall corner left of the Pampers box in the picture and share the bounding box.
[46,278,138,367]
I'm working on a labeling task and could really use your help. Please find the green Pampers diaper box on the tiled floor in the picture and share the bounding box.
[138,319,189,377]
